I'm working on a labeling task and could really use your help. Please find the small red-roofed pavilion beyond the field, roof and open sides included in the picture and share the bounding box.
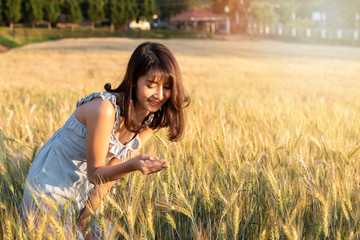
[170,8,230,34]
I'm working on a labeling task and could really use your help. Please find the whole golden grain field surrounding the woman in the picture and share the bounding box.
[0,38,360,239]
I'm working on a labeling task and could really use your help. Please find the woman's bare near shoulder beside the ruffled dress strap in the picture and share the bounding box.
[75,98,115,126]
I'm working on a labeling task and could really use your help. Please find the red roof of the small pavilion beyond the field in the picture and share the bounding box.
[170,8,223,21]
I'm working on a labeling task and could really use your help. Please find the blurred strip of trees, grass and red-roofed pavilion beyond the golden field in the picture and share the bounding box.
[0,0,360,48]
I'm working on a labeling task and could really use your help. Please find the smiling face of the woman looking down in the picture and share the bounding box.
[135,75,171,112]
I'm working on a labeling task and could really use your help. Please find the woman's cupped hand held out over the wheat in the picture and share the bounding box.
[129,154,170,175]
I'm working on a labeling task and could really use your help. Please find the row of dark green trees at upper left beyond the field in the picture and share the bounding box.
[0,0,156,31]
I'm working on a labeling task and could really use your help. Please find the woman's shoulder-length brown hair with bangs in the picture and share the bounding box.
[104,42,190,141]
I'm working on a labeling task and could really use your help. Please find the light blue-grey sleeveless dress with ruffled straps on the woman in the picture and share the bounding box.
[20,92,145,239]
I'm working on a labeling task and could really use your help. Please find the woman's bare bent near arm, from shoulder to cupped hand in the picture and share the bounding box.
[79,99,166,184]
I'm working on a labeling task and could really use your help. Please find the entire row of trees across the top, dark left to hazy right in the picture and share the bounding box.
[0,0,360,32]
